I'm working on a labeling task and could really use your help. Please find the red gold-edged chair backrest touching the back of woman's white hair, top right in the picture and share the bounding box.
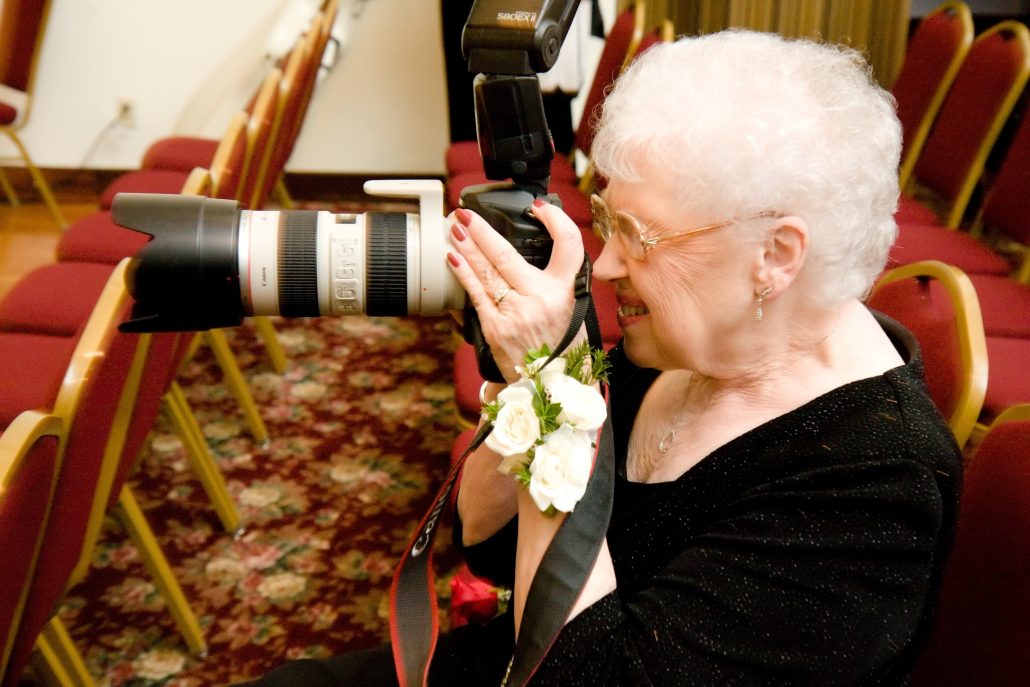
[891,0,973,188]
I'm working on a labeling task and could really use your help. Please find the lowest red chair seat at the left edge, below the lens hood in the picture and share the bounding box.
[0,332,75,427]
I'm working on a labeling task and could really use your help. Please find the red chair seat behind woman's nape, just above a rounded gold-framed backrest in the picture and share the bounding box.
[887,224,1012,276]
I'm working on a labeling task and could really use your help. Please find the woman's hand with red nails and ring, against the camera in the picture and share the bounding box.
[447,200,583,381]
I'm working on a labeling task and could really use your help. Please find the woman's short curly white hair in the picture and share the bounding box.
[591,30,901,307]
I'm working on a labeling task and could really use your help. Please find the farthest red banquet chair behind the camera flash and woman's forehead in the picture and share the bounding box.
[445,1,647,185]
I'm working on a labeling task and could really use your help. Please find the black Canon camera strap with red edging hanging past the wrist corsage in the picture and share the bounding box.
[389,254,615,687]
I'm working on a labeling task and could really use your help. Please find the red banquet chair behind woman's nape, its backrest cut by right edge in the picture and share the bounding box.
[888,97,1030,280]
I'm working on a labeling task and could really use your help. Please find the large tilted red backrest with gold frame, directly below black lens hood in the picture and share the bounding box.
[2,259,146,687]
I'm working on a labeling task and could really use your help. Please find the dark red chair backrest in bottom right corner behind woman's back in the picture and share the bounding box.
[913,405,1030,687]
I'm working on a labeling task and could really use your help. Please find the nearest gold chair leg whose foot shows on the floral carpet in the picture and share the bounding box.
[114,485,207,656]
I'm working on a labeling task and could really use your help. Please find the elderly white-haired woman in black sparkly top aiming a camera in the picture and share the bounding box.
[245,32,960,685]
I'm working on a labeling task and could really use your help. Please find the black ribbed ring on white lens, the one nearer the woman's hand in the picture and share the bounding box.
[365,212,408,316]
